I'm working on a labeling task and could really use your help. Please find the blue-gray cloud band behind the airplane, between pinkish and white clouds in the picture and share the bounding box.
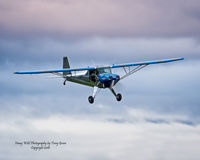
[0,38,200,123]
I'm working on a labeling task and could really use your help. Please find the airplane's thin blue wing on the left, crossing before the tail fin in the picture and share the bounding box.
[14,67,95,74]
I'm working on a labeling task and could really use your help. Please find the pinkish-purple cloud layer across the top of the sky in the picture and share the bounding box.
[0,0,200,37]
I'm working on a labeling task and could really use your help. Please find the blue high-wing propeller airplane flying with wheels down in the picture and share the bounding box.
[15,57,184,103]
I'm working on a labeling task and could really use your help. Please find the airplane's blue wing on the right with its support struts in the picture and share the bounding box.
[111,58,184,79]
